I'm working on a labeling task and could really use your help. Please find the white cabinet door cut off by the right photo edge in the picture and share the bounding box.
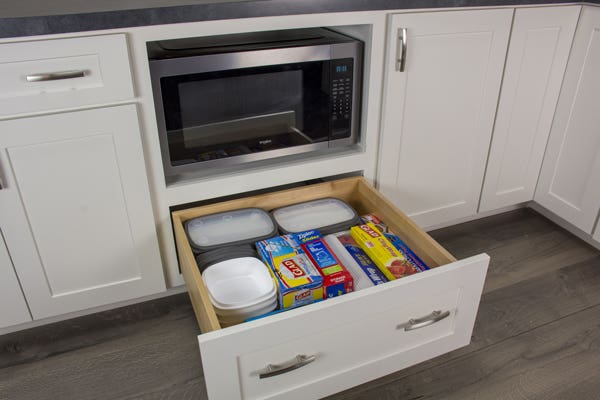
[534,7,600,233]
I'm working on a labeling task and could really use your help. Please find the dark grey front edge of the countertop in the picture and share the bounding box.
[0,0,600,38]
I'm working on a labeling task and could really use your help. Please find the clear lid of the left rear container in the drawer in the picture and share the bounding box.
[185,208,277,251]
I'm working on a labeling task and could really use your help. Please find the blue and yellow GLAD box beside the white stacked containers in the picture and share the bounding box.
[256,231,323,309]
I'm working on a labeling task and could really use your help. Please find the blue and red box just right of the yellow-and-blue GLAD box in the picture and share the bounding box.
[302,238,354,299]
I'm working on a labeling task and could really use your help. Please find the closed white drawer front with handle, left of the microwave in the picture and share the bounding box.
[0,34,133,116]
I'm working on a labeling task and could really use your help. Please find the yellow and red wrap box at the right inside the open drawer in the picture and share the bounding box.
[350,222,419,280]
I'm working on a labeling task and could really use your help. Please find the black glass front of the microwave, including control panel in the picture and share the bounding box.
[161,59,353,166]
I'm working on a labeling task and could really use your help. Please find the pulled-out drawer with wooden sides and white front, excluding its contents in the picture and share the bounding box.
[173,177,489,400]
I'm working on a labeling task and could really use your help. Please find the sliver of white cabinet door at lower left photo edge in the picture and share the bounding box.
[0,230,31,328]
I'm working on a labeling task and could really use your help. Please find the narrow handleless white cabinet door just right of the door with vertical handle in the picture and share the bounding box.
[479,6,581,211]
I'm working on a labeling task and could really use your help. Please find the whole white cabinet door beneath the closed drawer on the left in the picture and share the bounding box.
[0,105,165,318]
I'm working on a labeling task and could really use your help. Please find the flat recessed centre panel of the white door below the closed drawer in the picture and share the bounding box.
[8,134,141,296]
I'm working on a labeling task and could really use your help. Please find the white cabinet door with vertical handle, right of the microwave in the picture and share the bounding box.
[378,9,513,227]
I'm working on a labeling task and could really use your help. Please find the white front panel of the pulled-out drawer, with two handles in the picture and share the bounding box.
[199,255,489,400]
